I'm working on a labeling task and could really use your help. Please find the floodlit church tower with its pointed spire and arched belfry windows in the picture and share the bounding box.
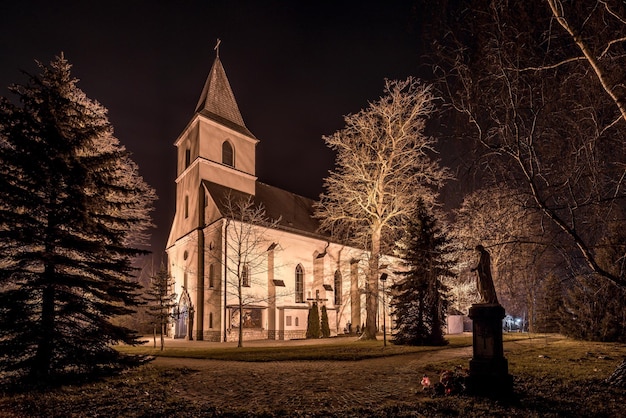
[166,48,259,339]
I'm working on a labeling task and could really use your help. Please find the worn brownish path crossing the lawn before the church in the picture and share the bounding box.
[151,339,539,411]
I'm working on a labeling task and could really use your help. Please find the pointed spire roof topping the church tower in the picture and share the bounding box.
[195,56,255,138]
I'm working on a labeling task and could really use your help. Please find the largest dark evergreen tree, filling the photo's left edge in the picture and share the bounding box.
[0,56,156,382]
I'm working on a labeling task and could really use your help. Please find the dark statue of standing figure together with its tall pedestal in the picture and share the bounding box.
[467,245,513,397]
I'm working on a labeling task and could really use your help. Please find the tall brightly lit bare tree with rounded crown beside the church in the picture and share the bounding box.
[316,78,450,339]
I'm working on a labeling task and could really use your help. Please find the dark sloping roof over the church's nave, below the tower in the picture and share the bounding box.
[203,180,323,237]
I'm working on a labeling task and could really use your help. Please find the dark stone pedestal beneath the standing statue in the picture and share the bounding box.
[467,303,513,396]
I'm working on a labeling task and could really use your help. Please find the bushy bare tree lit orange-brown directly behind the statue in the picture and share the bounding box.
[454,186,555,326]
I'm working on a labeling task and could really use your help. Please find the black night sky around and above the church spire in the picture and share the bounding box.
[0,0,438,258]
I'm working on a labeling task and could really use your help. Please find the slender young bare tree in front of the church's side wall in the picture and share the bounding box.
[209,194,280,347]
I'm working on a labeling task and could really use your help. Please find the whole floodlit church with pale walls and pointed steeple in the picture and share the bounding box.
[166,50,392,342]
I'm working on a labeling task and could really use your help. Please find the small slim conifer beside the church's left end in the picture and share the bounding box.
[144,266,176,351]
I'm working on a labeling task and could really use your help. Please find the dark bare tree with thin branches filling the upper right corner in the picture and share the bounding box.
[437,1,626,286]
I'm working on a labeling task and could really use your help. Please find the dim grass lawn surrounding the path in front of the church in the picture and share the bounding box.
[0,334,626,418]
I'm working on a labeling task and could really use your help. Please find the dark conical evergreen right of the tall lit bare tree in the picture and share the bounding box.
[390,200,454,345]
